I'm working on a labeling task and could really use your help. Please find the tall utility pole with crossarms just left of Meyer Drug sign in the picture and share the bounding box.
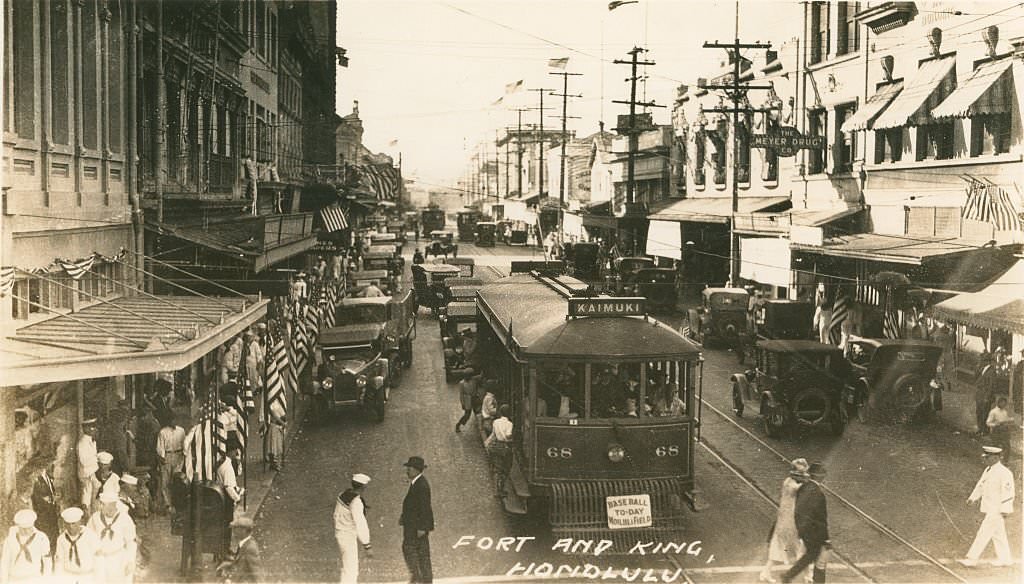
[702,2,771,286]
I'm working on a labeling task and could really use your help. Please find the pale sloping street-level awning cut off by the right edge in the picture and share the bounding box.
[931,260,1024,334]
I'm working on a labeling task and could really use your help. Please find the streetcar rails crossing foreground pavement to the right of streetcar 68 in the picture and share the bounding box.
[698,400,968,583]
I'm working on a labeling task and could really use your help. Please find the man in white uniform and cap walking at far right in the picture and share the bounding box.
[961,446,1016,566]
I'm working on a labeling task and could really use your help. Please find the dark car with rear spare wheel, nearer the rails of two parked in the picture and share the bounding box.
[732,340,850,437]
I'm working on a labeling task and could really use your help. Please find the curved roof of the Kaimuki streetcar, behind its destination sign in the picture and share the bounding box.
[478,274,700,359]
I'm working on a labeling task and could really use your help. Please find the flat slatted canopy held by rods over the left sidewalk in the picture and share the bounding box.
[0,295,268,386]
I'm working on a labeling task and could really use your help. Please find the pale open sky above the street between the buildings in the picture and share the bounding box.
[337,0,802,187]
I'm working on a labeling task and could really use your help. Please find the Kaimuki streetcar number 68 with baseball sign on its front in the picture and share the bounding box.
[477,262,703,553]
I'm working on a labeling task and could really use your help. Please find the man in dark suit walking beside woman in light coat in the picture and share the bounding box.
[782,462,829,582]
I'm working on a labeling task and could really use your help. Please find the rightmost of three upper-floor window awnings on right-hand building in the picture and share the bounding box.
[932,57,1014,119]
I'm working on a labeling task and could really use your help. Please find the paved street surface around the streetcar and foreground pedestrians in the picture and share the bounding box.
[249,244,1020,582]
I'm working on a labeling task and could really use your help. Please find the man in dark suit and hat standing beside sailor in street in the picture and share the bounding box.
[398,456,434,582]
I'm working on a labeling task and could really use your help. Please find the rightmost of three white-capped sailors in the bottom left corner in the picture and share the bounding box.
[88,491,137,583]
